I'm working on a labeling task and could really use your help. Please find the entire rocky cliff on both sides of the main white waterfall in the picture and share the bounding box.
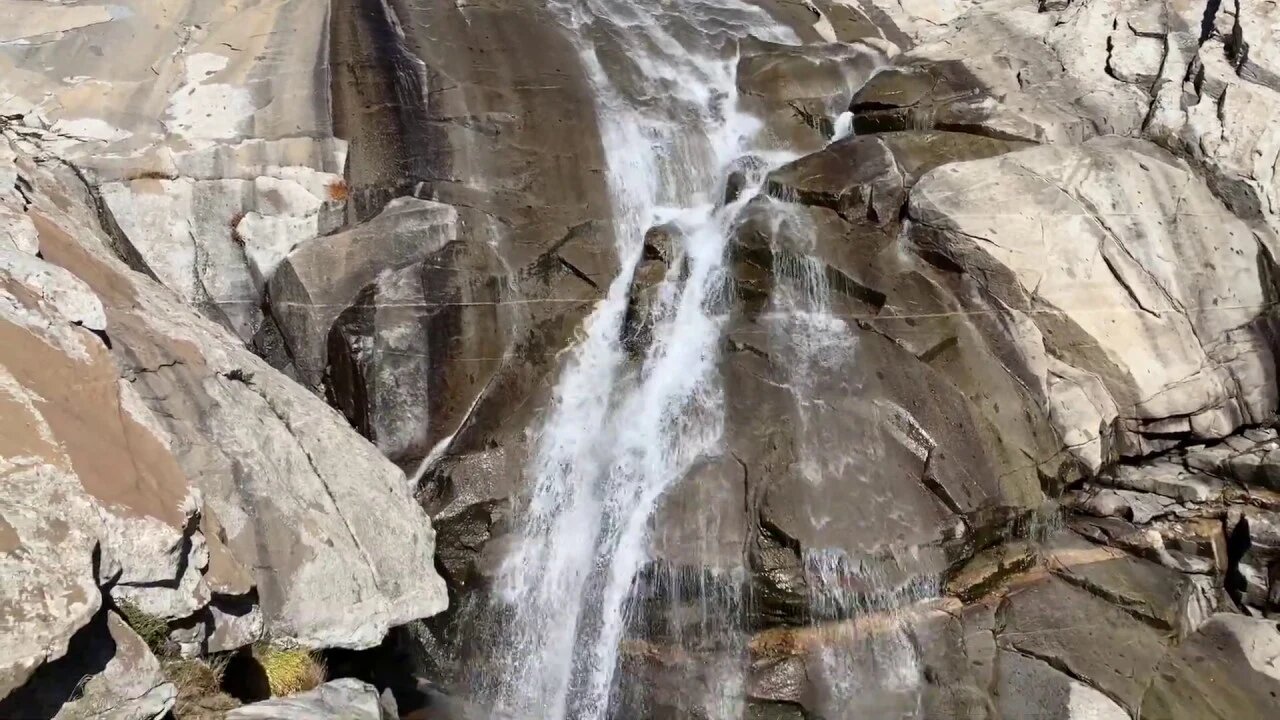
[0,0,1280,720]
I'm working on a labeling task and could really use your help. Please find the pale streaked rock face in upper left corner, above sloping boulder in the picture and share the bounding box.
[0,0,347,341]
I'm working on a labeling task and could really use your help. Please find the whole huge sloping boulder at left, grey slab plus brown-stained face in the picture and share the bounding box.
[0,128,447,712]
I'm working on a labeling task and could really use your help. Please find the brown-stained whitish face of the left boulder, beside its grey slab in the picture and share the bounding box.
[0,229,199,697]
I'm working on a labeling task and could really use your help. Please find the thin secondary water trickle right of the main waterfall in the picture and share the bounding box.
[768,189,937,720]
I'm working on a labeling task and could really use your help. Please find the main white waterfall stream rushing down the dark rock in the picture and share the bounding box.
[476,0,911,720]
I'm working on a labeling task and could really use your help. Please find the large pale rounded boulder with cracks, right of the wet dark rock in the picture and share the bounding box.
[909,138,1276,470]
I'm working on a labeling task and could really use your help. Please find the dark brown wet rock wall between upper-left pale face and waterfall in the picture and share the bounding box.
[325,0,617,478]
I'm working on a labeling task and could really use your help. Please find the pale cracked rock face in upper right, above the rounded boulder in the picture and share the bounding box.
[850,0,1280,233]
